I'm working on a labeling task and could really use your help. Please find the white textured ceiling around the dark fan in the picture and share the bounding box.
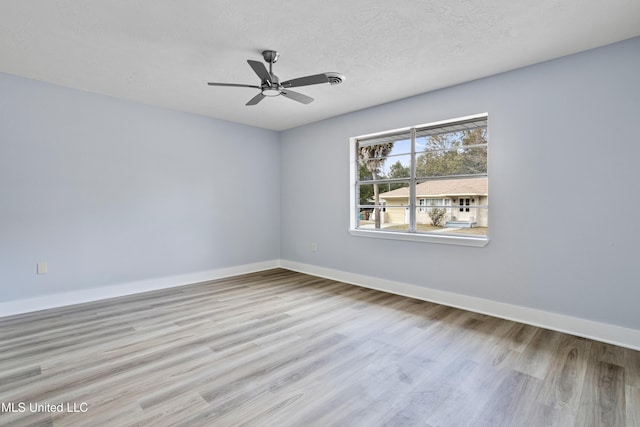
[0,0,640,130]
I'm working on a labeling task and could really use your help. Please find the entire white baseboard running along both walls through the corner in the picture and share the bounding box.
[0,260,640,350]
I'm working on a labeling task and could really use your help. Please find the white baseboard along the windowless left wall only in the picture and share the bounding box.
[0,260,280,317]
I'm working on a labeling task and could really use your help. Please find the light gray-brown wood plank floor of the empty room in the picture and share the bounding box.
[0,269,640,427]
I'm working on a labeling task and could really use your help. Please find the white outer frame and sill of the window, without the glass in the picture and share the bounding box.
[349,113,489,247]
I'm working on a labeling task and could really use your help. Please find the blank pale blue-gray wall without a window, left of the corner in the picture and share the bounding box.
[0,74,280,302]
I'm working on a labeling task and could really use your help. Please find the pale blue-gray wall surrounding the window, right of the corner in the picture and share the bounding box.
[281,38,640,329]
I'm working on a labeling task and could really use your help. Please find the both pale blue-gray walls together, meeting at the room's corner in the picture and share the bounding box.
[0,38,640,329]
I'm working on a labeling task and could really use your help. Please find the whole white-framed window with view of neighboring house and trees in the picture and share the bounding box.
[350,114,489,246]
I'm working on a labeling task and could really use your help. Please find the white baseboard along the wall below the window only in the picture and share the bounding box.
[280,260,640,350]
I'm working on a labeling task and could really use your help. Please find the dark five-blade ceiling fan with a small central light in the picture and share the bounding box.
[207,50,345,105]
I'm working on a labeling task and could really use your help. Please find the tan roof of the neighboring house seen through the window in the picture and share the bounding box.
[380,177,488,199]
